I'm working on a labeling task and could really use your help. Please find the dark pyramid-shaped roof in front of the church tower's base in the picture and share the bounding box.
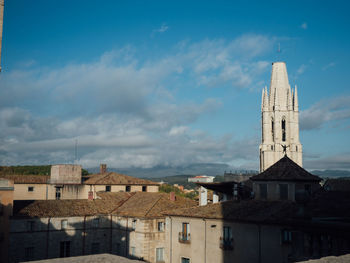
[250,156,321,181]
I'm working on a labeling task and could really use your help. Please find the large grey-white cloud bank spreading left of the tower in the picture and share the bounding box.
[0,35,274,167]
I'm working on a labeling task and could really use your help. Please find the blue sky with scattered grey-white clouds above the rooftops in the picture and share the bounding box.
[0,0,350,170]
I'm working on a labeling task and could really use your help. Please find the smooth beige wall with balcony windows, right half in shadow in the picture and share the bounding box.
[166,217,290,263]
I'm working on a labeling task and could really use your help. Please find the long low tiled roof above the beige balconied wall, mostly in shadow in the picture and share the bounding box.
[166,191,350,226]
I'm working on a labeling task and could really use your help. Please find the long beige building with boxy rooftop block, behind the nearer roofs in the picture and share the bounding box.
[0,164,159,200]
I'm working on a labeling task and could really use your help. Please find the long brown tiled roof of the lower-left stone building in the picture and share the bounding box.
[14,192,196,218]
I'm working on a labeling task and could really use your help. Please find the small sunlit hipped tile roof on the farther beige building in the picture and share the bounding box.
[84,172,159,185]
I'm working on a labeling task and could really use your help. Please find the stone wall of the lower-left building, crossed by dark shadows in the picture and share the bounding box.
[9,215,165,262]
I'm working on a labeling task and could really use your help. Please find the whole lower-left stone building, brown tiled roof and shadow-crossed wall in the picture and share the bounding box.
[9,192,195,262]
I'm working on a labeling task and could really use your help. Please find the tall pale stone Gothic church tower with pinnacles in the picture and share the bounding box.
[259,62,303,172]
